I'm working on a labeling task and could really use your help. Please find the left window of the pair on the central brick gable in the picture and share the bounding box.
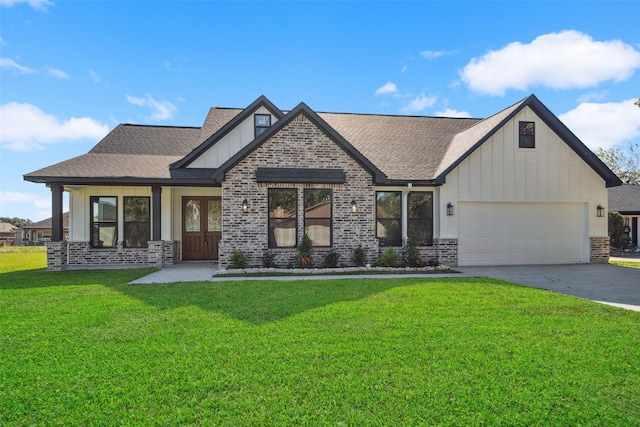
[269,188,298,248]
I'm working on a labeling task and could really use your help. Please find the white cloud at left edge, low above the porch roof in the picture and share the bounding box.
[0,102,109,151]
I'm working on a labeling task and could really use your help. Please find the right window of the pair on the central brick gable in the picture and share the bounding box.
[304,188,333,246]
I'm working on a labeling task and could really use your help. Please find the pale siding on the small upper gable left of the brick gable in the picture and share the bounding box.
[187,107,278,168]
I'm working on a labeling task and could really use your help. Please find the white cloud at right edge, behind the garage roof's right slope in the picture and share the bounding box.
[558,99,640,151]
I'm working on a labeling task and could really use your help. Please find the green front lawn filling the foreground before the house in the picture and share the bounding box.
[0,253,640,426]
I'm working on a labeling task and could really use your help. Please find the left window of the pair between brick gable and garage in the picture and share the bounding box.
[376,191,402,246]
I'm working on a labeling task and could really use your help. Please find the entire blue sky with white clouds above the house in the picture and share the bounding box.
[0,0,640,221]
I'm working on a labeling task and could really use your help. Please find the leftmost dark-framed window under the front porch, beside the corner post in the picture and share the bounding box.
[90,196,118,248]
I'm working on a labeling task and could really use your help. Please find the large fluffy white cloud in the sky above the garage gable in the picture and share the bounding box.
[460,30,640,95]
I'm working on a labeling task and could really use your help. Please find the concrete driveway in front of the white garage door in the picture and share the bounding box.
[456,263,640,311]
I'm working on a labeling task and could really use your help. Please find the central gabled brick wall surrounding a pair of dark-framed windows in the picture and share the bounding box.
[219,113,378,267]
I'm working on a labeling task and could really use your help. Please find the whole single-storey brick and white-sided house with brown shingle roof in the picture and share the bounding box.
[25,95,621,270]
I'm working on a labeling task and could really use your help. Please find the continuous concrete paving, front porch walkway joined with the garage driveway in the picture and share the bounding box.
[130,258,640,311]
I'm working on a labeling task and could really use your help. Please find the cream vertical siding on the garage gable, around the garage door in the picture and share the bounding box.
[440,108,607,238]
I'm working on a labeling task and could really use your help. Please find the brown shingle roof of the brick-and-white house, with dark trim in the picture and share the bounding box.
[25,95,620,186]
